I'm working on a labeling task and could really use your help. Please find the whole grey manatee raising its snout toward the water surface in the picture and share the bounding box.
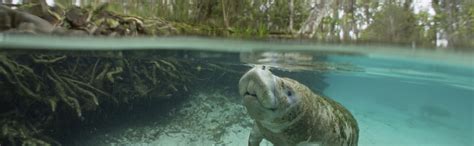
[239,66,359,146]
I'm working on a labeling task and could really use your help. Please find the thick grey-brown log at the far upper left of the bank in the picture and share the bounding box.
[0,5,54,34]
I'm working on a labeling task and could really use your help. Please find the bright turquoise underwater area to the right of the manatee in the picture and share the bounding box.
[324,54,474,145]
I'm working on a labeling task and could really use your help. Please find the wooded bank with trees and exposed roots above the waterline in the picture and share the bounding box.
[0,0,474,50]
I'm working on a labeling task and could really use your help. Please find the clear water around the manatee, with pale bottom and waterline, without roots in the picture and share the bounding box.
[0,36,474,146]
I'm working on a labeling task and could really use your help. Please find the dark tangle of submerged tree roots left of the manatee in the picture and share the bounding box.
[0,52,219,145]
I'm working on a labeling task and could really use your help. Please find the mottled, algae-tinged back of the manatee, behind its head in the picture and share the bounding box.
[285,78,359,146]
